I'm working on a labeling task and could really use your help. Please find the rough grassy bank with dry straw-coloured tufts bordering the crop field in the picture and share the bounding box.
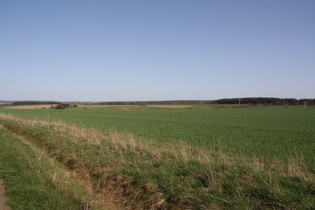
[0,115,315,209]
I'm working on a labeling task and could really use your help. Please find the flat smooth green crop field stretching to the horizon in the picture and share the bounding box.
[1,107,315,160]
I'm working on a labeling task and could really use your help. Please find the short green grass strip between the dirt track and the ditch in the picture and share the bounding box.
[0,125,117,210]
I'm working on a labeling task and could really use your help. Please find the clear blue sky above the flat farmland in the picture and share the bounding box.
[0,0,315,101]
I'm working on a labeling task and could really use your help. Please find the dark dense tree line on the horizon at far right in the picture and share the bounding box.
[213,98,315,106]
